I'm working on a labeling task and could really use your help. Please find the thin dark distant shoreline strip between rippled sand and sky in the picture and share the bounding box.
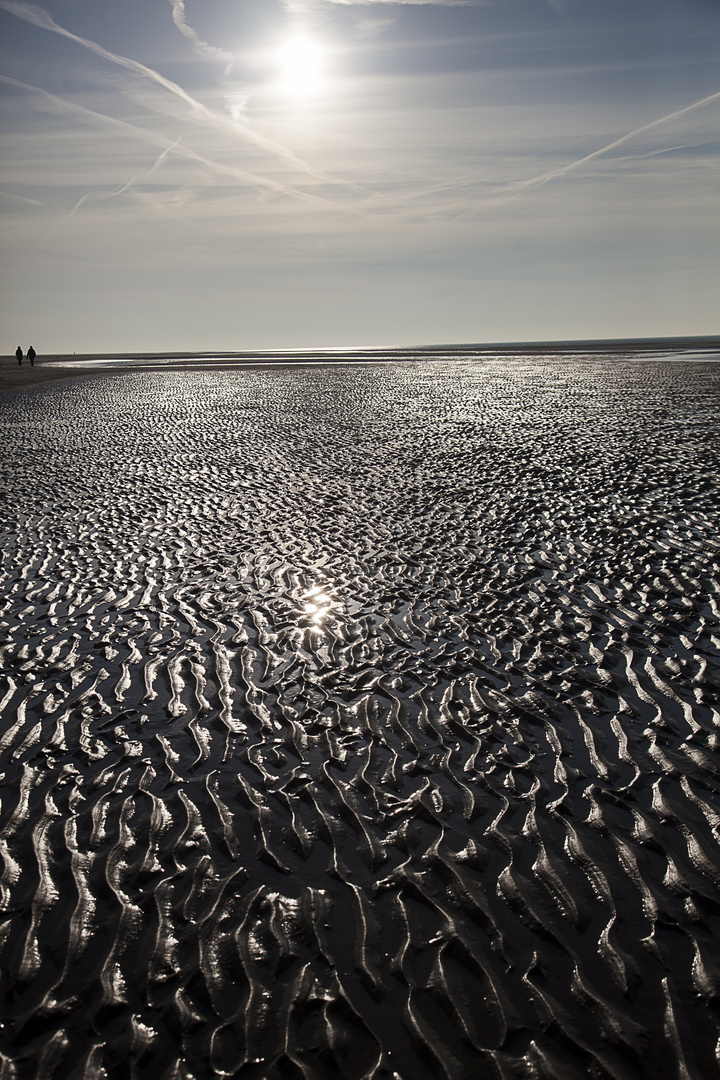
[0,336,720,393]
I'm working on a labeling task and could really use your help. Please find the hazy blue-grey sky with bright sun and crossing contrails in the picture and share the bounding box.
[0,0,720,354]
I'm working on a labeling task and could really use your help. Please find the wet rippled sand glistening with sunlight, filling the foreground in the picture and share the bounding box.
[0,357,720,1080]
